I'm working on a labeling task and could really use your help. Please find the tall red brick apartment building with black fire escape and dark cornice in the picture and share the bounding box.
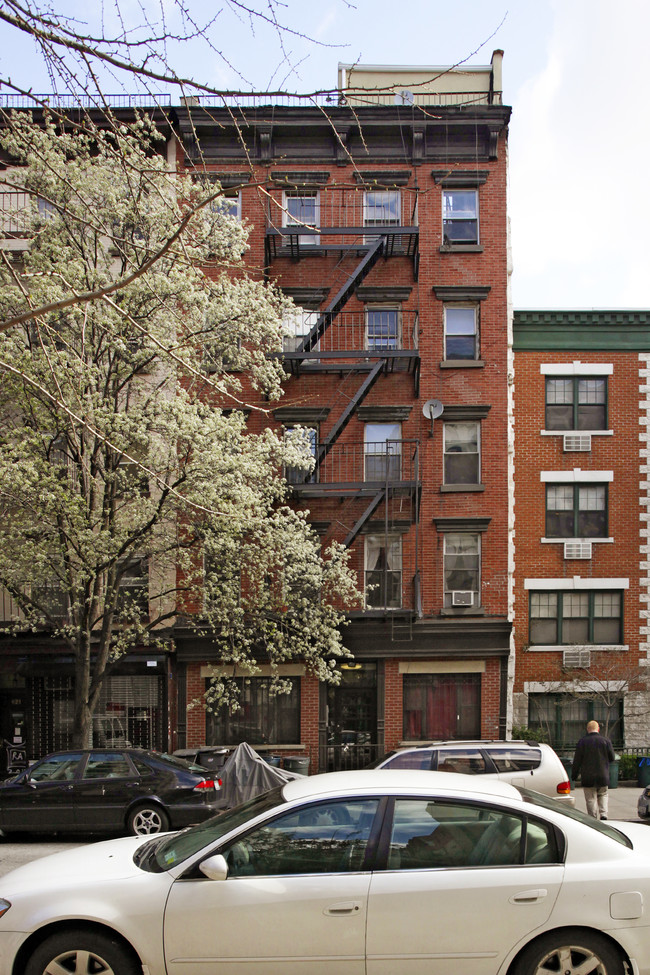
[172,52,510,771]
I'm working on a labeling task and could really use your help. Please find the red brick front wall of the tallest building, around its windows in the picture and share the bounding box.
[171,70,510,770]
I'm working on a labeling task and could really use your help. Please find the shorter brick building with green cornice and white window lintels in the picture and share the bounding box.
[513,311,650,749]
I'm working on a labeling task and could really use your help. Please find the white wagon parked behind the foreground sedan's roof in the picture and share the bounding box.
[369,741,575,805]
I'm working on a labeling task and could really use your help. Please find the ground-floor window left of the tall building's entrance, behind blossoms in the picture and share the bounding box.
[206,677,300,745]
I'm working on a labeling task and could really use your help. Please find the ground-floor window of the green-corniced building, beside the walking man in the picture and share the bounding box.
[528,691,624,754]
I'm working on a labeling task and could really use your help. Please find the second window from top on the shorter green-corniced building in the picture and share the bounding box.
[546,484,607,538]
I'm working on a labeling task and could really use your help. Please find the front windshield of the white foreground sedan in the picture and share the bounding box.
[133,786,284,873]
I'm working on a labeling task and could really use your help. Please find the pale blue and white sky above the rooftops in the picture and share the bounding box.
[0,0,650,309]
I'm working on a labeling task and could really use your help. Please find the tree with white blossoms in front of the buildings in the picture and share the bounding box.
[0,115,356,746]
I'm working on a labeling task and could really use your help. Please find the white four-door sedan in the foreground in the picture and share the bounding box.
[0,771,650,975]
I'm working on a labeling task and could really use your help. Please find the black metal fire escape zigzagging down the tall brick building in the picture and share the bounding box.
[265,189,421,639]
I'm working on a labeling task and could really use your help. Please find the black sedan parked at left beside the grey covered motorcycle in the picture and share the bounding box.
[0,748,221,836]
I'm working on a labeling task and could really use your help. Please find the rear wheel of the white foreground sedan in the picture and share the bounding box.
[514,928,625,975]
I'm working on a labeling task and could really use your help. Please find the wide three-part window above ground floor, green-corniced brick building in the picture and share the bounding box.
[529,590,623,646]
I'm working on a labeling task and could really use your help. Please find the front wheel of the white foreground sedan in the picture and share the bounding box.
[25,931,142,975]
